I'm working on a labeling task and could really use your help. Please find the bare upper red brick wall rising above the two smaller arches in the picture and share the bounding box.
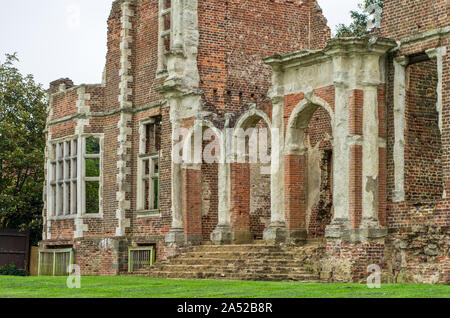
[198,0,330,112]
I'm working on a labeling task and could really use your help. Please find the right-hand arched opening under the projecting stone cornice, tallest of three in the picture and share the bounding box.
[285,98,333,240]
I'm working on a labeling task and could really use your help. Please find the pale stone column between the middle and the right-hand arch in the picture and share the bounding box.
[264,94,287,244]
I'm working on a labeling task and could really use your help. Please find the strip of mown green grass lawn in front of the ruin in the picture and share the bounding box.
[0,276,450,298]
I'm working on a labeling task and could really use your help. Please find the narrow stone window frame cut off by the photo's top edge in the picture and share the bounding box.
[156,0,173,78]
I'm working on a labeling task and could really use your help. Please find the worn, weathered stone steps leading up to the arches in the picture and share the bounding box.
[130,244,326,282]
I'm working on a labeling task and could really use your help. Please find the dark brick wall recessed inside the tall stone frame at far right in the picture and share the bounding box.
[405,60,443,204]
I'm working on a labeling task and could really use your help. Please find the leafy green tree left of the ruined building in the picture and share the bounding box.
[0,54,47,244]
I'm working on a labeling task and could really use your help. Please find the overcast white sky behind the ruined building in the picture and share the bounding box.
[0,0,360,88]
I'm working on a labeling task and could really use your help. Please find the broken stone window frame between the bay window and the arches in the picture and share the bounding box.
[136,117,162,218]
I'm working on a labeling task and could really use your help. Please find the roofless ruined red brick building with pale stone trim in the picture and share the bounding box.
[40,0,450,283]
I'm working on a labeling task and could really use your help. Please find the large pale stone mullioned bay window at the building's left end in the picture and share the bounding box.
[47,133,104,220]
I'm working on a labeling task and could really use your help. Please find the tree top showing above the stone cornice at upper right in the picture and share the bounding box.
[336,0,384,37]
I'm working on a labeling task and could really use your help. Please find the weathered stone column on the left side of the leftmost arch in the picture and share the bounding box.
[166,118,184,244]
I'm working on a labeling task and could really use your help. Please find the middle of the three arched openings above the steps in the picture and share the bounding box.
[230,109,271,243]
